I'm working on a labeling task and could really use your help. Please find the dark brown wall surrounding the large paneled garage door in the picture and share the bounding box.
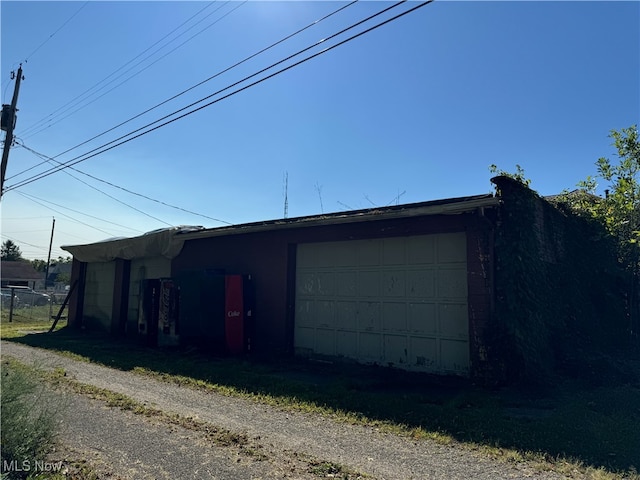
[172,214,492,375]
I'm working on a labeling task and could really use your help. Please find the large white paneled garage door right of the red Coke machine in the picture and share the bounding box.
[294,233,469,375]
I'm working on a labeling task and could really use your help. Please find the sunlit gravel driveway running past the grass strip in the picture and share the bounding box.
[1,342,563,480]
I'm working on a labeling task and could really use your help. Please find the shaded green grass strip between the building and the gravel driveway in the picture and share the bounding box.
[0,321,640,479]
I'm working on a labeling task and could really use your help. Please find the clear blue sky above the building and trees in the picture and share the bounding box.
[0,0,640,258]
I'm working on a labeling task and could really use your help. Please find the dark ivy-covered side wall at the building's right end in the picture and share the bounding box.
[492,176,628,381]
